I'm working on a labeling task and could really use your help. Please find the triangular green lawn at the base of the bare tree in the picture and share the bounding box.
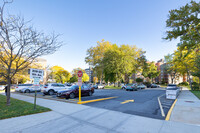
[0,95,51,120]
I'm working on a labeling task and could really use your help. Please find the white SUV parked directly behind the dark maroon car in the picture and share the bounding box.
[41,83,69,95]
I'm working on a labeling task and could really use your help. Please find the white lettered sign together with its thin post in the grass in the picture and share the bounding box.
[29,68,44,109]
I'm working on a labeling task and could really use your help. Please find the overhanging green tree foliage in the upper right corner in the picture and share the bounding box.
[165,1,200,52]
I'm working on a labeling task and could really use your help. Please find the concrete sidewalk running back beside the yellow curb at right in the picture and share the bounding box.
[170,88,200,126]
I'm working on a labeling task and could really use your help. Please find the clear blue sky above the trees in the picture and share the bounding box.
[2,0,195,71]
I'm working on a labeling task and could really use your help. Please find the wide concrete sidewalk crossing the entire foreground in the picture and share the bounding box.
[0,94,200,133]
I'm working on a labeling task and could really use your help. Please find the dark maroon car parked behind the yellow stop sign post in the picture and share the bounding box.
[57,84,94,98]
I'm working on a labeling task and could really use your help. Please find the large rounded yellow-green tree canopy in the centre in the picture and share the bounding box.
[85,40,146,82]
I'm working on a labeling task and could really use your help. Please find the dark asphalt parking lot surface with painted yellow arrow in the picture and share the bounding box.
[13,88,174,119]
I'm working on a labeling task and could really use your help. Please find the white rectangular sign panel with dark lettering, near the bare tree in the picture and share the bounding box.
[30,68,44,80]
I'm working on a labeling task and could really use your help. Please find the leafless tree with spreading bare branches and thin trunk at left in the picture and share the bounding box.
[0,1,62,105]
